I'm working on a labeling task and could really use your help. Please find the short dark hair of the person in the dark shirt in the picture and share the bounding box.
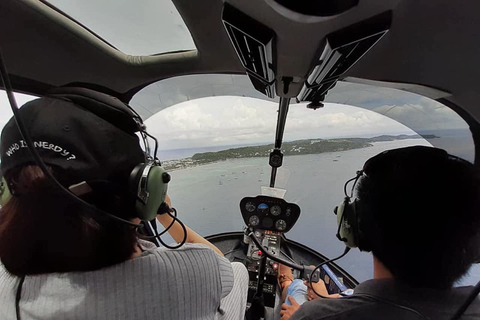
[357,154,480,288]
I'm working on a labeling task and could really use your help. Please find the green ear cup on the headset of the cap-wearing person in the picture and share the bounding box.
[136,166,168,221]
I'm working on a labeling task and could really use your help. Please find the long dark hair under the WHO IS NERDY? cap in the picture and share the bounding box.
[0,166,137,276]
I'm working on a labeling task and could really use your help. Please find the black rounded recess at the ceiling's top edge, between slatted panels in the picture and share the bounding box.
[275,0,358,17]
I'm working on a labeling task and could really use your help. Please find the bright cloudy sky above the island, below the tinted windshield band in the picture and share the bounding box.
[146,96,414,150]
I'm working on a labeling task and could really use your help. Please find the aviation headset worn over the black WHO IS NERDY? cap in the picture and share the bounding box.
[0,87,170,222]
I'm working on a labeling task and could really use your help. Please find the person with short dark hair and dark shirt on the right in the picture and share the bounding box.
[282,147,480,320]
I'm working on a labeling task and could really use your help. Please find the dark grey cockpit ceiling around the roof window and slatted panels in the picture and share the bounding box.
[0,0,480,127]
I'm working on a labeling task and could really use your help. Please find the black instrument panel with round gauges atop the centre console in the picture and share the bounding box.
[240,196,300,233]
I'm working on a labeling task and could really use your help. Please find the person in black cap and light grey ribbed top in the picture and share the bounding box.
[0,92,248,320]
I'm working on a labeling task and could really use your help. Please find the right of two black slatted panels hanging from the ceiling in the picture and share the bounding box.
[297,12,391,101]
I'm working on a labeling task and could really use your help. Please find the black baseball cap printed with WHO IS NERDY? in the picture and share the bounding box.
[0,95,146,188]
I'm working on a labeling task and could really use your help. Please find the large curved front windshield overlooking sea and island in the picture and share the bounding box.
[131,75,474,283]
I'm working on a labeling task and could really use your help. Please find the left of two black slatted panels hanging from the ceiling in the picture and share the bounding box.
[222,3,275,98]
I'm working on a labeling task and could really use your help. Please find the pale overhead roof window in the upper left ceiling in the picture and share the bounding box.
[47,0,196,56]
